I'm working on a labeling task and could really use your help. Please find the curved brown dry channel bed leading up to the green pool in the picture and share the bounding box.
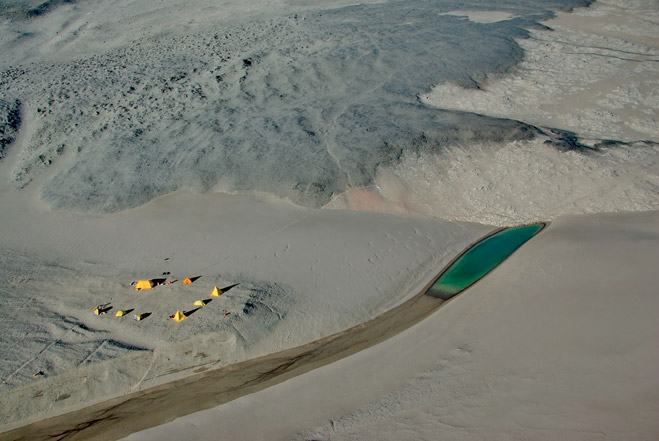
[0,222,548,440]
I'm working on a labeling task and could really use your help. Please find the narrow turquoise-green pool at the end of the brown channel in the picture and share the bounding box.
[427,224,544,300]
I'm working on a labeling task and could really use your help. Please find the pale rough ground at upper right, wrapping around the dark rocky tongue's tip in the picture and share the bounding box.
[330,0,659,225]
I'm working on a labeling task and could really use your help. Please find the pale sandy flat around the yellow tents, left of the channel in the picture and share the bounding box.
[0,184,492,427]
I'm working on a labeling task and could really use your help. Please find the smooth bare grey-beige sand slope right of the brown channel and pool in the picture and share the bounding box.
[127,212,659,441]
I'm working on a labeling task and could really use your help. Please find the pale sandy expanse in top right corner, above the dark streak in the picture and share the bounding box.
[423,0,659,142]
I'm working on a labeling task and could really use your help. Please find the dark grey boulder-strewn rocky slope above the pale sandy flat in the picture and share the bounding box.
[0,1,587,211]
